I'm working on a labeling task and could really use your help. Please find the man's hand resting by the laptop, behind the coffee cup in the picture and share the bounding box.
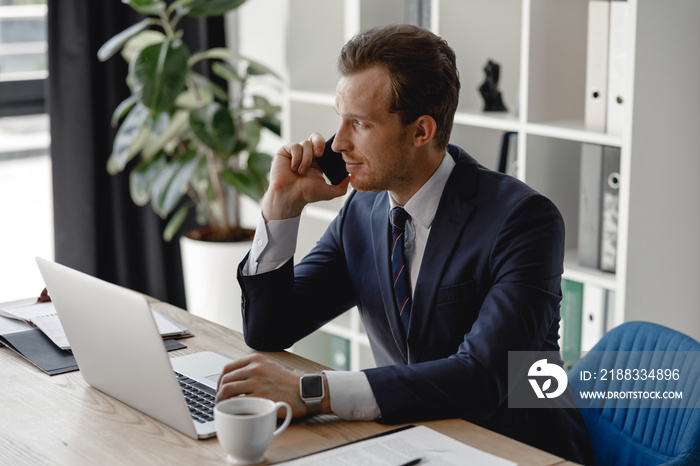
[216,353,316,417]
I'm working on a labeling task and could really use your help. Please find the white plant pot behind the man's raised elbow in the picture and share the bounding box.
[180,236,252,332]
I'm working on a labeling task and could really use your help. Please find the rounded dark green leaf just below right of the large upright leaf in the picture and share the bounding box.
[190,102,236,154]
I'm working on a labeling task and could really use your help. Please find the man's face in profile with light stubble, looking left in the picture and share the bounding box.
[333,66,415,193]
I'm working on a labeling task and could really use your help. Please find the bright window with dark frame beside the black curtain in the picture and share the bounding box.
[0,0,53,303]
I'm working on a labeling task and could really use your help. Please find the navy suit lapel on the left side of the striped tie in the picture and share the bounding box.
[371,193,408,362]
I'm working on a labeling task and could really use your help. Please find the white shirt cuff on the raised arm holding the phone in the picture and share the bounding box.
[243,214,301,275]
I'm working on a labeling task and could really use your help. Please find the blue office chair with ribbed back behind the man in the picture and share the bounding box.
[568,322,700,466]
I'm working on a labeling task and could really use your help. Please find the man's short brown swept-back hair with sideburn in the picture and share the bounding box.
[338,24,459,149]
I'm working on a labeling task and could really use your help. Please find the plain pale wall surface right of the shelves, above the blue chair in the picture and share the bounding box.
[625,0,700,340]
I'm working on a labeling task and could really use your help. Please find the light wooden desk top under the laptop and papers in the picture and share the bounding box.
[0,303,564,466]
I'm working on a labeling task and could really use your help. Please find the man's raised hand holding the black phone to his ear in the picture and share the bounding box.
[262,133,350,221]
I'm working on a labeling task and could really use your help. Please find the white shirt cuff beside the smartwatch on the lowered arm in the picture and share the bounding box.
[323,371,381,421]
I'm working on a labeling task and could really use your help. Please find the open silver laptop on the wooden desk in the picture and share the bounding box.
[36,257,231,439]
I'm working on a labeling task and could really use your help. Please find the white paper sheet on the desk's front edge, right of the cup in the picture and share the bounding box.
[278,426,516,466]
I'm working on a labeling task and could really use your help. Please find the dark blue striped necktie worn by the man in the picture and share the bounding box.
[391,207,412,334]
